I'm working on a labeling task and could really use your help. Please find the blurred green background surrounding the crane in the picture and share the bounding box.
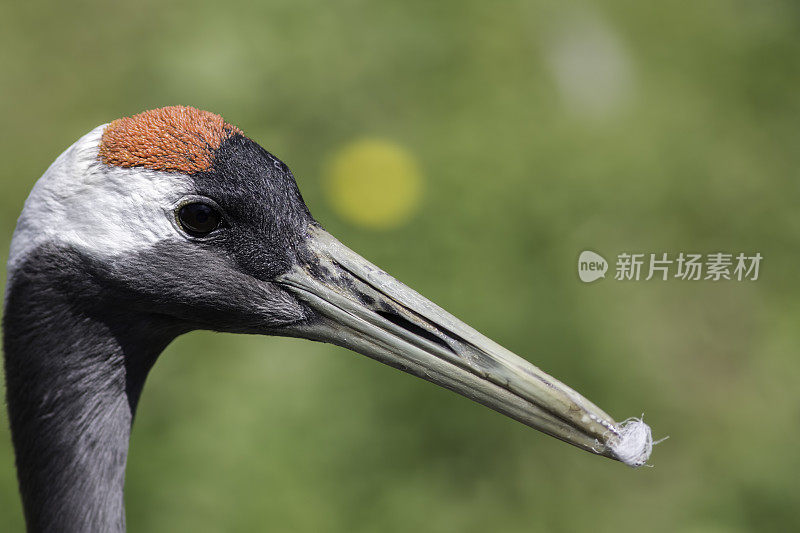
[0,0,800,532]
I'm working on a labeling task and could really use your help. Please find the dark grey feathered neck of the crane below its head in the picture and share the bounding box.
[3,248,180,532]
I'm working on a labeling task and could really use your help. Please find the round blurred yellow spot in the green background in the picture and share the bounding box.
[325,139,422,229]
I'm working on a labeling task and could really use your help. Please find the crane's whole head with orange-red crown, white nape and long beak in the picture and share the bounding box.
[9,106,652,466]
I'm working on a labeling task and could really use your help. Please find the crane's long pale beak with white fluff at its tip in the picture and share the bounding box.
[277,226,652,466]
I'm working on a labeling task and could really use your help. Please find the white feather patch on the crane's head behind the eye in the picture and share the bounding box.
[8,125,193,278]
